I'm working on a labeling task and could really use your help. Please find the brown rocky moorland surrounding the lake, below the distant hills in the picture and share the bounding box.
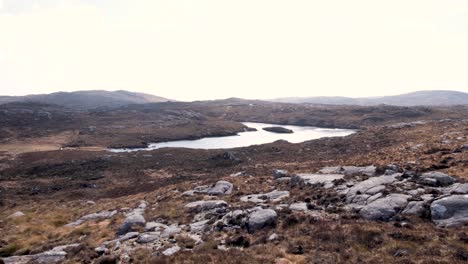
[0,92,468,264]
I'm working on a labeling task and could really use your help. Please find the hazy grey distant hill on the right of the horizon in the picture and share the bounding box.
[271,90,468,106]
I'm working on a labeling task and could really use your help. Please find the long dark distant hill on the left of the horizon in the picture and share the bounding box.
[0,90,171,110]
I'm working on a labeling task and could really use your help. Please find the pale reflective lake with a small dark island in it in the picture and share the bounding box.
[110,122,356,152]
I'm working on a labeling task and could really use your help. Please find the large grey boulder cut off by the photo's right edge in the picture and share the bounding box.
[431,195,468,227]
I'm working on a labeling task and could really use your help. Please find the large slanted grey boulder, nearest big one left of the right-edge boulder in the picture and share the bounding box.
[359,194,411,221]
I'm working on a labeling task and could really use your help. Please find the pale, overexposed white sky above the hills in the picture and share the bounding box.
[0,0,468,100]
